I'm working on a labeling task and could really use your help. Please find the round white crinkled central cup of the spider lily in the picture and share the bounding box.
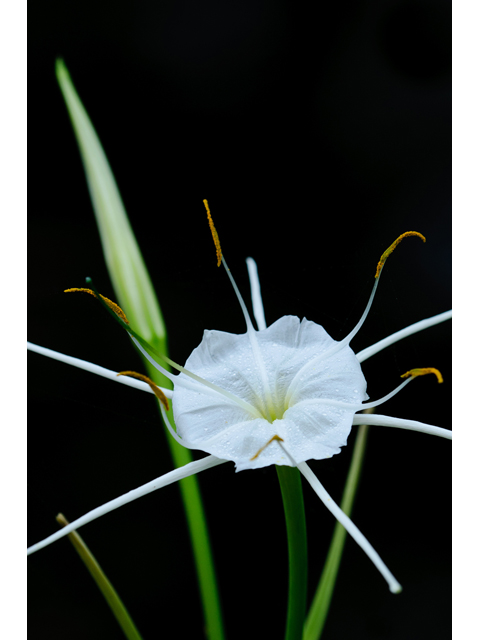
[173,316,367,470]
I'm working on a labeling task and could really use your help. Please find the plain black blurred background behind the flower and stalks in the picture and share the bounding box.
[28,0,451,640]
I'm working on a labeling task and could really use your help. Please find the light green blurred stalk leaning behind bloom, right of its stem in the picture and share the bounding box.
[303,420,373,640]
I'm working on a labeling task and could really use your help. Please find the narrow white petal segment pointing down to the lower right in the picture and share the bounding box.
[297,462,402,593]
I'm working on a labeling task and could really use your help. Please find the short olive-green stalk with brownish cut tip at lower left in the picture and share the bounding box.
[57,513,142,640]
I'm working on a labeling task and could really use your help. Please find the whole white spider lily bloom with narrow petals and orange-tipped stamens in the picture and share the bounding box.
[28,206,451,593]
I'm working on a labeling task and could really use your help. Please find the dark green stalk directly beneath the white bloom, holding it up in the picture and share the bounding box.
[277,466,307,640]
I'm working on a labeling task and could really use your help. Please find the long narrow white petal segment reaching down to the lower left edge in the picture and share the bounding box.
[27,456,226,555]
